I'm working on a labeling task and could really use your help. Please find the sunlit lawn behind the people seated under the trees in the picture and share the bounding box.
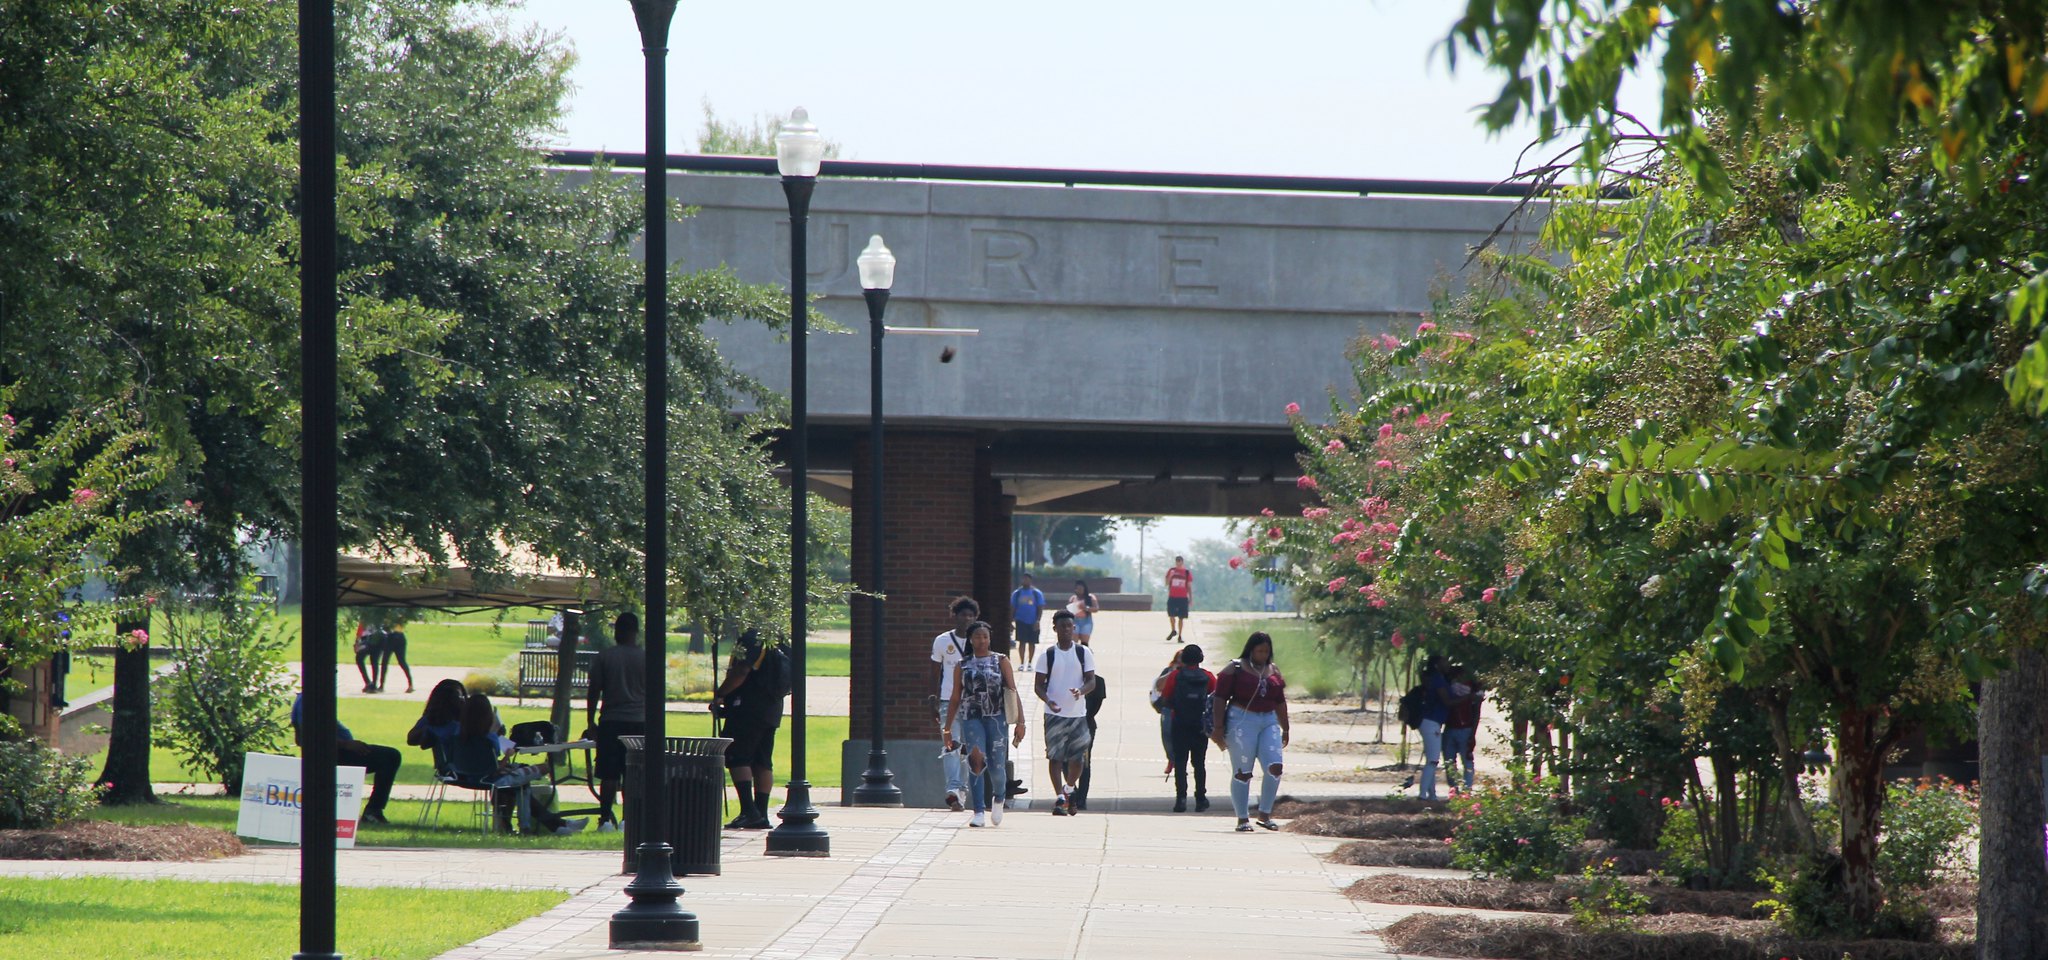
[92,696,848,790]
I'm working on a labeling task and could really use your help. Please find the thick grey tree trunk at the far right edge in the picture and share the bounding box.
[1976,649,2048,960]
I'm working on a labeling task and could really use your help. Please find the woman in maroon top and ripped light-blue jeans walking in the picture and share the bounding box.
[1208,630,1288,833]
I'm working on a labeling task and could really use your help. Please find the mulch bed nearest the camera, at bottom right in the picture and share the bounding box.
[1380,913,1976,960]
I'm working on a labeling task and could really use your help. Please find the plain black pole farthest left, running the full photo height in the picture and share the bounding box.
[293,0,342,960]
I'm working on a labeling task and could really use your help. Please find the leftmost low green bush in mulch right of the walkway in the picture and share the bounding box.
[1450,765,1585,880]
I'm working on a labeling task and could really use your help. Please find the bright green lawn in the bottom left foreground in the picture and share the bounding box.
[0,876,567,960]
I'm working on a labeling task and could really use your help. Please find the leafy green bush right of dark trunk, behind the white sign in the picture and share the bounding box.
[152,592,295,794]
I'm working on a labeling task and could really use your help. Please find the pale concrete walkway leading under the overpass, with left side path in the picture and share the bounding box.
[0,614,1450,960]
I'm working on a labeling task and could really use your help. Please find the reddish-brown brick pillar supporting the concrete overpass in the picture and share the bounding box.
[850,430,987,740]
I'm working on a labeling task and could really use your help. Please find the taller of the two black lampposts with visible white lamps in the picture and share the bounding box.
[766,106,831,858]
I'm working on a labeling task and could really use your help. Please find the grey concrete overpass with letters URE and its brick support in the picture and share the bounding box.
[614,164,1534,802]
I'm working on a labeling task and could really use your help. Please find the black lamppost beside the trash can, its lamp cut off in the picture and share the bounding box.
[610,0,698,950]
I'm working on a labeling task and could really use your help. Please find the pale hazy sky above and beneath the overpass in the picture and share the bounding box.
[504,0,1655,557]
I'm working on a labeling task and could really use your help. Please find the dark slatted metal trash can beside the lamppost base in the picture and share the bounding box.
[618,737,733,876]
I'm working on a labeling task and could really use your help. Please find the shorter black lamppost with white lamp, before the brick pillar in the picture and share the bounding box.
[854,233,903,806]
